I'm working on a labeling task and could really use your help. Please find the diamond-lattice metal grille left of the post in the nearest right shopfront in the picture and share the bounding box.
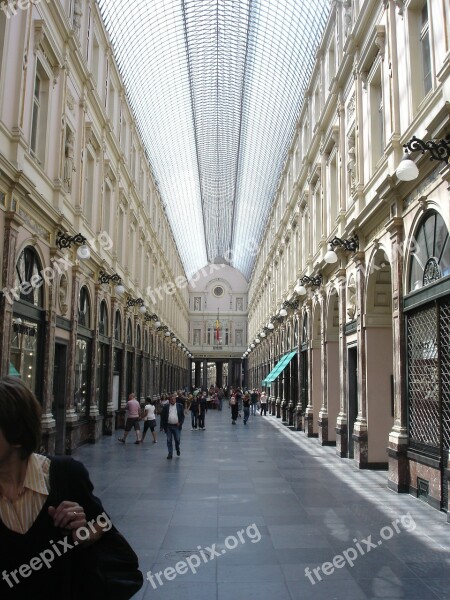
[407,306,440,454]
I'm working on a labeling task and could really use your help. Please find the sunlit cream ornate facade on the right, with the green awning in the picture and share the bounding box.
[246,0,450,510]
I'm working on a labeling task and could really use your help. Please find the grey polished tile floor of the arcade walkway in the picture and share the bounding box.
[74,405,450,600]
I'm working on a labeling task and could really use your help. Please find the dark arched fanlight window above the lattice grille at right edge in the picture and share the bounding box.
[408,211,450,292]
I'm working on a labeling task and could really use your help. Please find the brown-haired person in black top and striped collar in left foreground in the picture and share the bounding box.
[0,377,142,600]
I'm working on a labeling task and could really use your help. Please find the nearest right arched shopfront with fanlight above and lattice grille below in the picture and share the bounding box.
[404,211,450,510]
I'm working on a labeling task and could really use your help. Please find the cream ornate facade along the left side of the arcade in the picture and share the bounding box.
[0,0,190,452]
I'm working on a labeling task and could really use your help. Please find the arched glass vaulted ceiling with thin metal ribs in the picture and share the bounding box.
[99,0,329,279]
